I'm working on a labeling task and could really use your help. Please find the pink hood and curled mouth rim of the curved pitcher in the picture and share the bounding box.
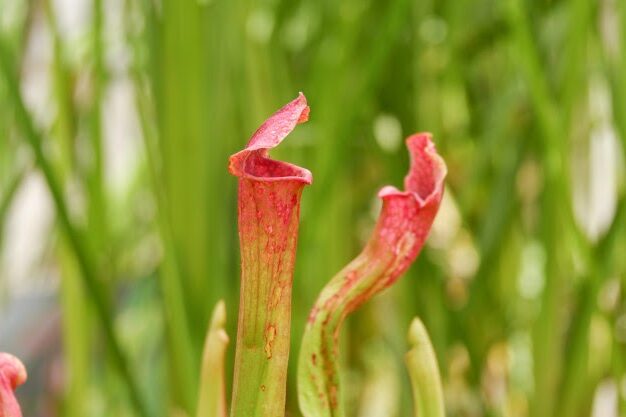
[378,132,448,207]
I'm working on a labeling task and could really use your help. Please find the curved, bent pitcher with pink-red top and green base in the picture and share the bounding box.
[298,134,446,417]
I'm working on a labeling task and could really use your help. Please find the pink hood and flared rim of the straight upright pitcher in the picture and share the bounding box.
[228,93,313,184]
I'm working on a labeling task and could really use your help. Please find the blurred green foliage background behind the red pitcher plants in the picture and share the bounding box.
[0,0,626,417]
